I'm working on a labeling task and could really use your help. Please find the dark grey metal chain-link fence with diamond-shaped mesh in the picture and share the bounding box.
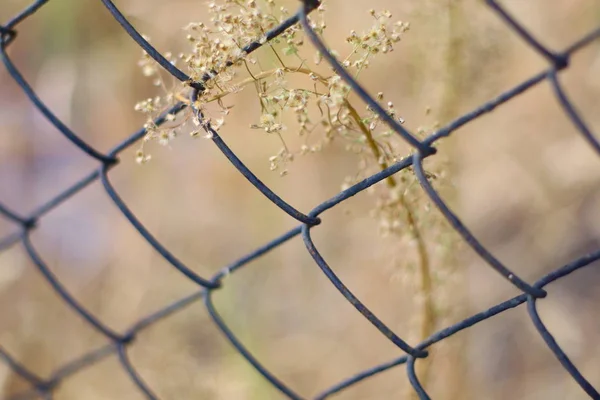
[0,0,600,400]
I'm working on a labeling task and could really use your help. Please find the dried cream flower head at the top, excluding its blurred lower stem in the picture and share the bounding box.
[135,0,409,178]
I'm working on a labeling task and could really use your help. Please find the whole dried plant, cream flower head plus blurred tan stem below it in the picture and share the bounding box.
[135,0,454,390]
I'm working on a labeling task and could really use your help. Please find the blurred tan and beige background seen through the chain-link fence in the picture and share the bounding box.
[0,0,600,400]
